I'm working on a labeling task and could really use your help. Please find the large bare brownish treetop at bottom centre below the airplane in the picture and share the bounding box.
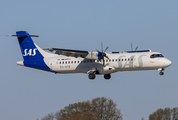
[49,97,122,120]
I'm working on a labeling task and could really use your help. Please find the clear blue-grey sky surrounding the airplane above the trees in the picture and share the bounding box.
[0,0,178,120]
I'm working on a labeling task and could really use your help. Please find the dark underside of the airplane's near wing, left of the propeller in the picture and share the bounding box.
[44,48,89,58]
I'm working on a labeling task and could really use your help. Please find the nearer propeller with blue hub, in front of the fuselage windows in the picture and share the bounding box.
[96,42,109,68]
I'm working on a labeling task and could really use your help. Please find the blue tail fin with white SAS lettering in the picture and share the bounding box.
[16,31,44,61]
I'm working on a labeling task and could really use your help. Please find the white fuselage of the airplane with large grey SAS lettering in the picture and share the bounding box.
[41,52,171,74]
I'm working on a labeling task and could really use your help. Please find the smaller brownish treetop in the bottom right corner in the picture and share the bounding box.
[149,108,178,120]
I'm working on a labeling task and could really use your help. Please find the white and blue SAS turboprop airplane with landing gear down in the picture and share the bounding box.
[7,31,172,80]
